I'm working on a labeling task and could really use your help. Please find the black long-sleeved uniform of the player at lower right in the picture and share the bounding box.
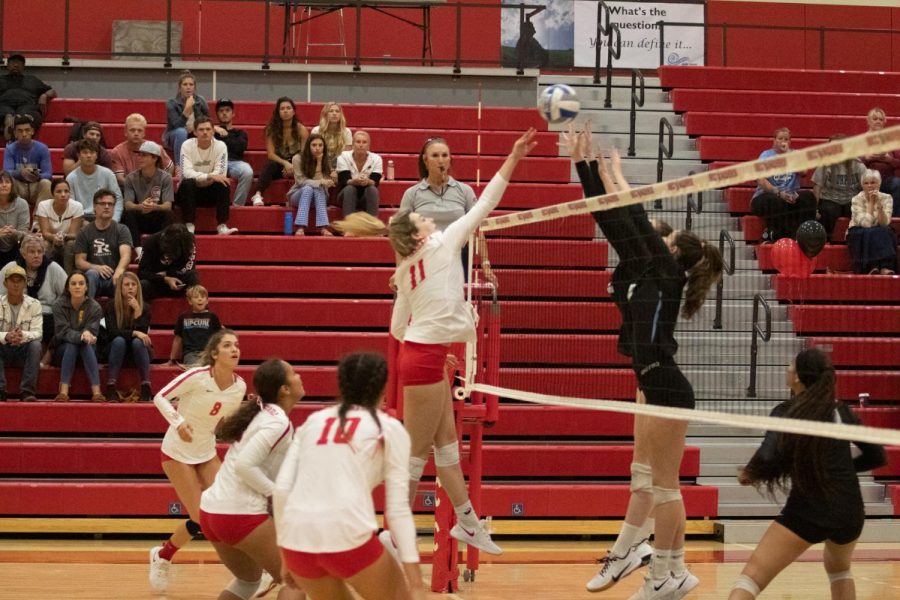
[750,401,886,544]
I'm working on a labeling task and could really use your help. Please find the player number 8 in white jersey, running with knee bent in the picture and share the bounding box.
[150,329,247,591]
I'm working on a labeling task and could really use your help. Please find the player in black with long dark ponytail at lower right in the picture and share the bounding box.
[728,348,885,600]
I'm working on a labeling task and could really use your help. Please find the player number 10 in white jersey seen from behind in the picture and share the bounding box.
[273,353,425,600]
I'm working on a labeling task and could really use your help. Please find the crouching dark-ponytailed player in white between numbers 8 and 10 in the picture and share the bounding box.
[200,359,304,600]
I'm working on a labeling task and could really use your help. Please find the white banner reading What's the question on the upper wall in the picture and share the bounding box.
[575,2,706,69]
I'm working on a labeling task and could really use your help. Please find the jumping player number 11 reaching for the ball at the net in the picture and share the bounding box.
[388,129,537,554]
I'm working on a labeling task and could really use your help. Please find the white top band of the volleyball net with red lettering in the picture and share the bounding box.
[481,125,900,231]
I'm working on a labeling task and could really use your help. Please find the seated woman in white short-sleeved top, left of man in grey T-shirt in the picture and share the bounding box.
[34,179,84,273]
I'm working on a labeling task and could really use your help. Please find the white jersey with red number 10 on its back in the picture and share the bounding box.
[273,406,419,563]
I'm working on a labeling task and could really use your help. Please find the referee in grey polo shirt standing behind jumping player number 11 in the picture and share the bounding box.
[400,138,475,231]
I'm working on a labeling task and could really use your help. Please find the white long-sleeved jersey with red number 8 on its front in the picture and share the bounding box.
[153,367,247,465]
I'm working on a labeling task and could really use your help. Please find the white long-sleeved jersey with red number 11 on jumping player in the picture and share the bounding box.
[391,173,508,344]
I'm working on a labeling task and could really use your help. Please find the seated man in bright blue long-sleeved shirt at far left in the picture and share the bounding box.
[3,115,53,207]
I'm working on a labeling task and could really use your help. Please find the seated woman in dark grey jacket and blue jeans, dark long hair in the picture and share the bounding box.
[51,272,102,402]
